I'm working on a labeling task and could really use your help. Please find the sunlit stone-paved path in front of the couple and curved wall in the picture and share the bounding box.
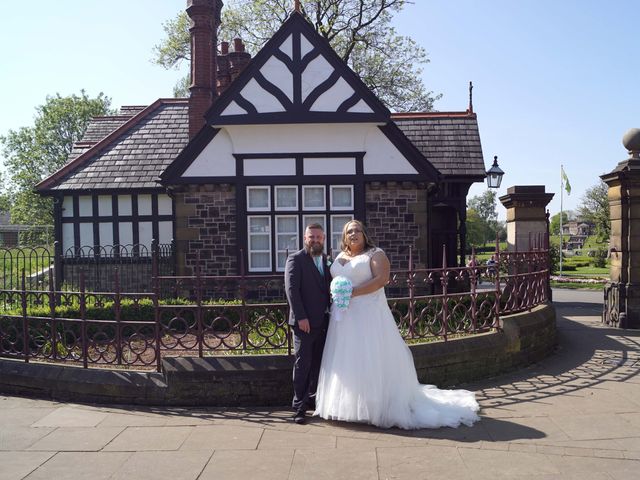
[0,290,640,480]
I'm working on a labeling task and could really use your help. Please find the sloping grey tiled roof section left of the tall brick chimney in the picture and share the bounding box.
[39,99,189,190]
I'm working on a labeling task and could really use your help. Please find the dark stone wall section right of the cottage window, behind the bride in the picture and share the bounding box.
[365,182,429,269]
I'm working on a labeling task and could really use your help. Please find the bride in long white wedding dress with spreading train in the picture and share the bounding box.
[314,220,480,429]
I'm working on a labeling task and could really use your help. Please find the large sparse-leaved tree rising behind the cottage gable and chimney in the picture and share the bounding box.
[153,0,442,112]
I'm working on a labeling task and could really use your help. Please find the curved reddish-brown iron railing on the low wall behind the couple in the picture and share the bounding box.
[0,244,549,371]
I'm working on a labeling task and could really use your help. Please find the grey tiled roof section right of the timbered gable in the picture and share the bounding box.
[391,112,486,179]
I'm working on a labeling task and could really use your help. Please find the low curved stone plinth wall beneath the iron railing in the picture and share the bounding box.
[0,304,556,407]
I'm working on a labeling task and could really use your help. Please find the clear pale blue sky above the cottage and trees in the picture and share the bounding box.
[0,0,640,217]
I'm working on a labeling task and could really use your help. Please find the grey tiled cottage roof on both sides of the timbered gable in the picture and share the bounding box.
[39,99,485,191]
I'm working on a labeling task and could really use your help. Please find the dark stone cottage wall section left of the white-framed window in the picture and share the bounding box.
[174,184,238,276]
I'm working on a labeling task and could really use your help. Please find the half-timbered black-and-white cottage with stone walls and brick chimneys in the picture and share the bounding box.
[38,0,485,288]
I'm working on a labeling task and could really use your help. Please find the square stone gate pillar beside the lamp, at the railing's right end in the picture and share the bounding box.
[500,185,553,252]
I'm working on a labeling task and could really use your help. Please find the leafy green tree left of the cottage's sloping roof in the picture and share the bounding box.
[0,90,112,231]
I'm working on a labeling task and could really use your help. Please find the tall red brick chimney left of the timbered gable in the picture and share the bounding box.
[187,0,222,138]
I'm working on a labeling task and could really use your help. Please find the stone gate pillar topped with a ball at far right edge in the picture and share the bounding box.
[600,128,640,328]
